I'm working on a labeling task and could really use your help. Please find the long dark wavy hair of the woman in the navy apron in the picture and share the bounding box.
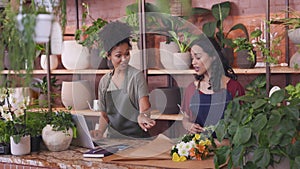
[192,36,237,91]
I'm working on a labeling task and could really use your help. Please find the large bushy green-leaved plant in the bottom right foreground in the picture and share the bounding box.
[215,76,300,168]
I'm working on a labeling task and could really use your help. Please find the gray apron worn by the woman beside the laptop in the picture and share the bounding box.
[105,69,149,138]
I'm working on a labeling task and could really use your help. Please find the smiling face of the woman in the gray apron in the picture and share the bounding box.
[108,42,130,71]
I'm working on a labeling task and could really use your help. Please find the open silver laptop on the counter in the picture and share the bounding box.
[71,114,130,150]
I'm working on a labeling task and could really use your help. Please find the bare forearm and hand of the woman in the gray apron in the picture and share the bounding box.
[137,96,156,131]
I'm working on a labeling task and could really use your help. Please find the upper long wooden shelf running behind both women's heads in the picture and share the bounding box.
[1,66,300,75]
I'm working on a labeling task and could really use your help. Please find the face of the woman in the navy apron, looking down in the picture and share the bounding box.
[191,45,215,75]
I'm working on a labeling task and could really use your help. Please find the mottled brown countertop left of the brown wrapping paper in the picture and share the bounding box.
[0,146,157,169]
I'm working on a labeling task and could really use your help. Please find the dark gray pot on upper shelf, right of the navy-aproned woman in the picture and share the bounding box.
[236,50,256,69]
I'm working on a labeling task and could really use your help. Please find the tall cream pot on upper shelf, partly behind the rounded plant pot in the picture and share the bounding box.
[159,42,179,69]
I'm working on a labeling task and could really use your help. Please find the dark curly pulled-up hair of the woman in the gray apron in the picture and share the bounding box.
[99,21,132,56]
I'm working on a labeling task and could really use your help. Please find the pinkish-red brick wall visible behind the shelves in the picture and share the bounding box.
[59,0,300,102]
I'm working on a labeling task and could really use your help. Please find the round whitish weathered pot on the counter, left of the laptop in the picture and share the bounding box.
[42,124,73,151]
